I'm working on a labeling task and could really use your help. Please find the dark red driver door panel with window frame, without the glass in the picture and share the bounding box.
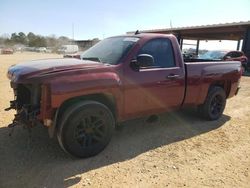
[123,35,185,119]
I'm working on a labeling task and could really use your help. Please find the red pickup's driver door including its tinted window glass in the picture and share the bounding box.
[124,38,185,116]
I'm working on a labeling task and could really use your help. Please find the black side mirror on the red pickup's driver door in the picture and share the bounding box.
[131,54,154,71]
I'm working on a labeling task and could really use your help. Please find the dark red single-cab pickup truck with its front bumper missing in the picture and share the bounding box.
[6,34,242,157]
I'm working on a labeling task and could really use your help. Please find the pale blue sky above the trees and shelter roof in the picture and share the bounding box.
[0,0,250,40]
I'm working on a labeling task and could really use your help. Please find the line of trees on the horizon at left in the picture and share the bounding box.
[0,32,70,47]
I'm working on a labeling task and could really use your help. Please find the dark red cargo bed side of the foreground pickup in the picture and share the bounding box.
[183,61,241,105]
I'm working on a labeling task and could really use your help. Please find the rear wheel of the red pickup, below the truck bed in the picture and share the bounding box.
[198,86,226,121]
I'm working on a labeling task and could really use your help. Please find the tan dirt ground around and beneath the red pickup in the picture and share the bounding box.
[0,53,250,188]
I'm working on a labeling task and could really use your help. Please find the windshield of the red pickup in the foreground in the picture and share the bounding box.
[81,37,139,65]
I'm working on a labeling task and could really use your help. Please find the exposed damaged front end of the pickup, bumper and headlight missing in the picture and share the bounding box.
[5,82,41,128]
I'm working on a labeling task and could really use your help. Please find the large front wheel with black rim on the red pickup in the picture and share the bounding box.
[57,101,115,158]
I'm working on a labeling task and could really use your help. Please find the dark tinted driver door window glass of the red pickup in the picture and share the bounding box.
[138,38,175,68]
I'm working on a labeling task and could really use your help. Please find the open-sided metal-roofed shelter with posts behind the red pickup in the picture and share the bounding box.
[127,21,250,64]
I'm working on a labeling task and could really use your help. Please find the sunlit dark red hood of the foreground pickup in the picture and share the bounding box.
[7,58,107,82]
